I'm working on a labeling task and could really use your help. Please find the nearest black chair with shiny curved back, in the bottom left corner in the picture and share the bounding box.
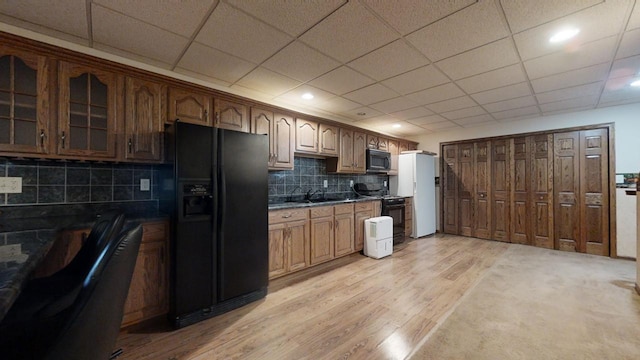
[0,225,142,360]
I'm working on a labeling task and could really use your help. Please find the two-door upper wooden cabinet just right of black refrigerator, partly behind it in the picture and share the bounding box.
[251,107,295,170]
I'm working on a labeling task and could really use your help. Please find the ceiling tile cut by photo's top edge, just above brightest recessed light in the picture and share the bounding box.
[501,0,602,32]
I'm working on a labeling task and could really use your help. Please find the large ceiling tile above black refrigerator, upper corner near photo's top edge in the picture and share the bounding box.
[195,3,293,63]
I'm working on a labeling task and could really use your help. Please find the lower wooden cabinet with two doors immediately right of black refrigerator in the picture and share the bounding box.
[269,209,309,279]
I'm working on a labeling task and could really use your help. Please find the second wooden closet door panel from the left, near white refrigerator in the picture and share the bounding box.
[458,143,475,236]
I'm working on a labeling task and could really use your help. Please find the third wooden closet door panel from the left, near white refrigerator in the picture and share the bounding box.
[472,141,491,239]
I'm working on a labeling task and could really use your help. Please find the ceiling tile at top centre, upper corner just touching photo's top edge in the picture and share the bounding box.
[300,1,398,63]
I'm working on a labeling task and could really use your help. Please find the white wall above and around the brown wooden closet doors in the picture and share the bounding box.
[412,104,640,258]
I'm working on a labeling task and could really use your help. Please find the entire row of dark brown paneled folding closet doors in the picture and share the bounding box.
[442,126,612,255]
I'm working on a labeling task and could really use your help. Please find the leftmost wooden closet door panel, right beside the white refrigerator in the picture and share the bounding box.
[442,143,459,234]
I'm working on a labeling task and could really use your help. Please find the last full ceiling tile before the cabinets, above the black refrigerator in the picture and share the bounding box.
[177,43,255,83]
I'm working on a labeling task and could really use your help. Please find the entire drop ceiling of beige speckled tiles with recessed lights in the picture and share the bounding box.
[0,0,640,136]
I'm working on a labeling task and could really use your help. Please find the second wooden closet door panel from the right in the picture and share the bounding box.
[553,131,581,251]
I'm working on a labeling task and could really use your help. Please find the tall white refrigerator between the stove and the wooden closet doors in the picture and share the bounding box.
[389,150,436,238]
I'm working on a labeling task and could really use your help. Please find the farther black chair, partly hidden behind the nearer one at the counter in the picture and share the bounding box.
[2,211,125,325]
